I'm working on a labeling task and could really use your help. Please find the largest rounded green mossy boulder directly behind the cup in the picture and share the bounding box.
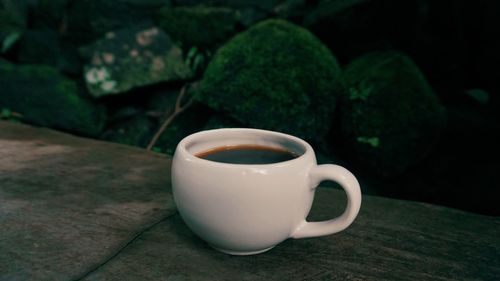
[197,19,340,139]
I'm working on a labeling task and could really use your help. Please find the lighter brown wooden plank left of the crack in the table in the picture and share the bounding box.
[0,122,175,280]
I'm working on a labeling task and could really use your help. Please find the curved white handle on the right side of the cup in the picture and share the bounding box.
[291,164,361,238]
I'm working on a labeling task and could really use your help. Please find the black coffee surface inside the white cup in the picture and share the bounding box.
[196,144,298,164]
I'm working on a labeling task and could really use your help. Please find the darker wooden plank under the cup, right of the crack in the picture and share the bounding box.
[87,185,500,280]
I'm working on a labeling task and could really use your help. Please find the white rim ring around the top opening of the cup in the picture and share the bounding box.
[174,128,313,167]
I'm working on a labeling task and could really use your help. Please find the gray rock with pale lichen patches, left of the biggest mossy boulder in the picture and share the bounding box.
[81,27,192,97]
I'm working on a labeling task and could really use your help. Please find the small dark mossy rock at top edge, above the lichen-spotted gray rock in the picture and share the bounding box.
[155,5,237,49]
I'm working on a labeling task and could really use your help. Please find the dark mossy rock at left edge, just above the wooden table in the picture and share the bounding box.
[0,62,105,136]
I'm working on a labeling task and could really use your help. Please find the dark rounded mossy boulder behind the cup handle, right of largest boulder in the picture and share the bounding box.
[340,51,445,176]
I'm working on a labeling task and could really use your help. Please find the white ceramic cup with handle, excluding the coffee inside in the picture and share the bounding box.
[172,128,361,255]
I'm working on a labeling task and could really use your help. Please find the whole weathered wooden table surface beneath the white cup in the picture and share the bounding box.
[0,122,500,281]
